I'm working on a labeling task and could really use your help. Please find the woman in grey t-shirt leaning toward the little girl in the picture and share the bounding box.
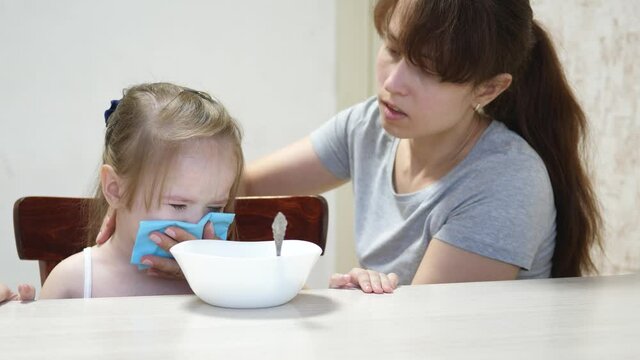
[99,0,600,292]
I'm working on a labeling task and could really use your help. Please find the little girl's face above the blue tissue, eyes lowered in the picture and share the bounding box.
[118,139,236,242]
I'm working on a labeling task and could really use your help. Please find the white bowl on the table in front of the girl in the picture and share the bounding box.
[171,240,322,308]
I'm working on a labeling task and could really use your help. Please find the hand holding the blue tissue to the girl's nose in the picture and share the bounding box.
[142,221,218,279]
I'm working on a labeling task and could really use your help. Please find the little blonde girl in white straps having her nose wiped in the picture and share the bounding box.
[40,83,243,299]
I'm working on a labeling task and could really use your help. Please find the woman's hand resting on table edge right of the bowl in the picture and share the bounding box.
[329,268,398,294]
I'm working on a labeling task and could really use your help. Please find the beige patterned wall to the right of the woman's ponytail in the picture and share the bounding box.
[532,0,640,274]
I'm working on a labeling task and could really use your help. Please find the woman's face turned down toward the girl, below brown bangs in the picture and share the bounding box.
[376,2,473,139]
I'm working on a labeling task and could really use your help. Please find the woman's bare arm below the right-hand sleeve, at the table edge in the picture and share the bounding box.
[411,238,519,285]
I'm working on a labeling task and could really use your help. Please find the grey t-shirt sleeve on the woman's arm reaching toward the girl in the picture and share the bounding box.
[310,98,376,179]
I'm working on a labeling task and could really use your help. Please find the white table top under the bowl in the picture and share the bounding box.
[0,275,640,360]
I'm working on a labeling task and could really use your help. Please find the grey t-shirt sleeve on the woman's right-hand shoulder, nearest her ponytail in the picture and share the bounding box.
[434,155,555,270]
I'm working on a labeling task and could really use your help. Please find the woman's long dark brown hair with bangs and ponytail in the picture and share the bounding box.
[374,0,602,277]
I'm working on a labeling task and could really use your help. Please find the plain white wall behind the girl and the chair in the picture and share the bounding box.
[0,0,336,287]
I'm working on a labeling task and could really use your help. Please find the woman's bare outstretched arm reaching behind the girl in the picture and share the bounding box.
[239,137,347,196]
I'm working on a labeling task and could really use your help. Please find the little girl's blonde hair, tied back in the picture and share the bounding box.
[87,83,244,245]
